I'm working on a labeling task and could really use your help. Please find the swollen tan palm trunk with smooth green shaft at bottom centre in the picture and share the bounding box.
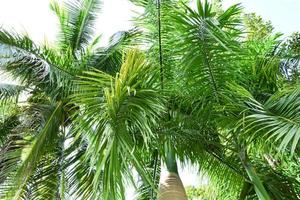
[157,142,187,200]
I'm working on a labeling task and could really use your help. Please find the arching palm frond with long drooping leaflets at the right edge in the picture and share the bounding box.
[232,86,300,154]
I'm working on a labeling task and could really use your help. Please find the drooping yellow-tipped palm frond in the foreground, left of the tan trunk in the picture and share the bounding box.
[73,51,165,199]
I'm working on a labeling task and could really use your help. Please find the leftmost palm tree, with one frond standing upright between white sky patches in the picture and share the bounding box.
[0,0,141,199]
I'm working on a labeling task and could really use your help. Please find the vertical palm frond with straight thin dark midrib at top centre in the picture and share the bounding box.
[132,0,182,88]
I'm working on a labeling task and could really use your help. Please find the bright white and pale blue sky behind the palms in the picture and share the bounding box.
[0,0,300,196]
